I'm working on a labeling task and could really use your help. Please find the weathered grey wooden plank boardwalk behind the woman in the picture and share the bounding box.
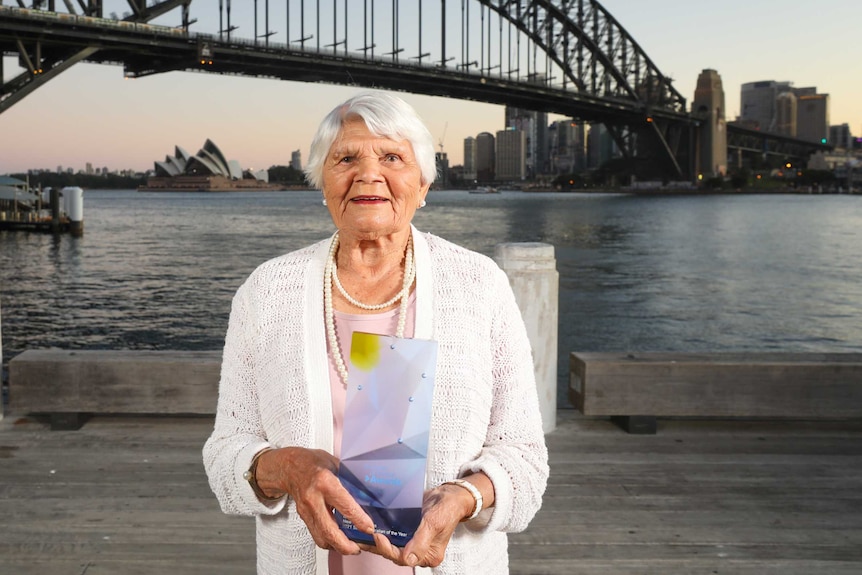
[0,411,862,575]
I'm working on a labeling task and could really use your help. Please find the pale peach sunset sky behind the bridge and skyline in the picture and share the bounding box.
[0,0,862,174]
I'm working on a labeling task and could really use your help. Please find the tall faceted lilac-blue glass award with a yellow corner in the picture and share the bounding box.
[335,332,437,547]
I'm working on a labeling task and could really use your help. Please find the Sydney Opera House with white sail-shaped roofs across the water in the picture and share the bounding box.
[139,140,282,192]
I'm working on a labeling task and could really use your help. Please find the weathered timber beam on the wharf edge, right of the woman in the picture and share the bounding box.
[569,352,862,433]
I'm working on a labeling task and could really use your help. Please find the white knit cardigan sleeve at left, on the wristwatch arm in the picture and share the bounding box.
[203,276,285,515]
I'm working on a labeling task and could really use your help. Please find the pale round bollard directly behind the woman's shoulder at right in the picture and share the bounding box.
[494,242,560,433]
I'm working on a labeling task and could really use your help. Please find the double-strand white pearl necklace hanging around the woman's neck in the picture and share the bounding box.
[323,232,416,388]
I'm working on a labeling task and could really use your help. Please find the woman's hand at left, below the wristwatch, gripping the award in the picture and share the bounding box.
[256,447,374,555]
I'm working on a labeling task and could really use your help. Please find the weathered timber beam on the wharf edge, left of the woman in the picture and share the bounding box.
[9,349,221,429]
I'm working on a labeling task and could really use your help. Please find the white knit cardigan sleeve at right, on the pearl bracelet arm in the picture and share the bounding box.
[461,268,548,532]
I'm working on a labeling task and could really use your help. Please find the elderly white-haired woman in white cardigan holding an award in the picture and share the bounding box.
[203,93,548,575]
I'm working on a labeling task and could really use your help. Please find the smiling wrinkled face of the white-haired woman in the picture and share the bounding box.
[323,118,429,240]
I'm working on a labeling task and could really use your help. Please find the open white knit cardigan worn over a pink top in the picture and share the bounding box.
[203,228,548,575]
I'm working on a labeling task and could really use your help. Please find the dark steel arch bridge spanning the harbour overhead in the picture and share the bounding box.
[0,0,825,181]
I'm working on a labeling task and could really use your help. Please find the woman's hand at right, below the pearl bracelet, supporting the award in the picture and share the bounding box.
[360,483,475,567]
